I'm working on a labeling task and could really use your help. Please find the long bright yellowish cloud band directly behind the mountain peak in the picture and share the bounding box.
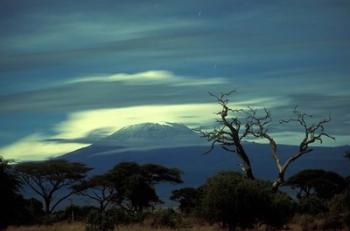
[0,99,288,160]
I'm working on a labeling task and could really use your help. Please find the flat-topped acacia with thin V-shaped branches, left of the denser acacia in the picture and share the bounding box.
[15,160,91,216]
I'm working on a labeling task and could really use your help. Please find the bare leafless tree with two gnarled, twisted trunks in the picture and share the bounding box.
[199,92,334,191]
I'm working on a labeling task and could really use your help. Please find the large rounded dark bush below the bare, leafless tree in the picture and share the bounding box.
[201,172,294,230]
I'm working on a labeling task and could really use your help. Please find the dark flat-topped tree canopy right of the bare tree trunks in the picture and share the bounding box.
[286,169,347,199]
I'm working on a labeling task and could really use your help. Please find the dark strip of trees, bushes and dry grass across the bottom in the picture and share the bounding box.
[0,153,350,231]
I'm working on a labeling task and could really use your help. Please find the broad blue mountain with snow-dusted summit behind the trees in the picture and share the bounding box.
[59,123,350,199]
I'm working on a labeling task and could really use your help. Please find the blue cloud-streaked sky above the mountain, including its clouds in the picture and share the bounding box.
[0,0,350,158]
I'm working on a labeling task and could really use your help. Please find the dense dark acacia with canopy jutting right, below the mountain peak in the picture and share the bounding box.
[107,162,182,212]
